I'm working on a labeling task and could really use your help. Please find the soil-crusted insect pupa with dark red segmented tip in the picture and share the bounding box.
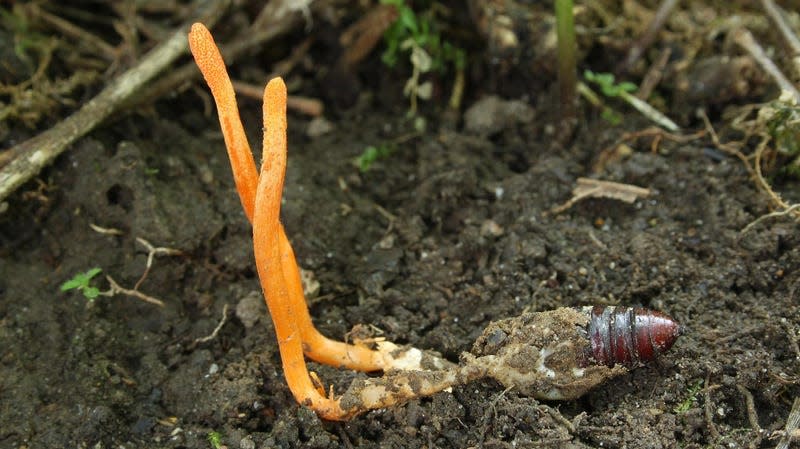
[465,306,680,400]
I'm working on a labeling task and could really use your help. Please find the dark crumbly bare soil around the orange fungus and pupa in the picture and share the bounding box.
[0,3,800,448]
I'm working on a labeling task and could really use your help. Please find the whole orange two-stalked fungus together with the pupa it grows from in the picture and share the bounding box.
[189,23,680,421]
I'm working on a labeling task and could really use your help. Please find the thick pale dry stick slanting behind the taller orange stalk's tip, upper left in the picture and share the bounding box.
[0,1,227,201]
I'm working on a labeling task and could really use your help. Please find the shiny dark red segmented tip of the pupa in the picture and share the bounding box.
[588,306,680,368]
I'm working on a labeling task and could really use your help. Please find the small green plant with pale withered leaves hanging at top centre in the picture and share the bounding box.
[381,0,467,116]
